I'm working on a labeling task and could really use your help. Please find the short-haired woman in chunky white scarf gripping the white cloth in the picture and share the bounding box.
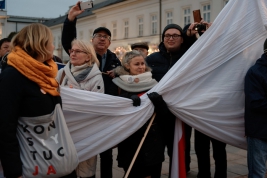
[110,50,169,178]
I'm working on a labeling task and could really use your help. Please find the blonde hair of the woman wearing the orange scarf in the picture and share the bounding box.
[10,23,53,59]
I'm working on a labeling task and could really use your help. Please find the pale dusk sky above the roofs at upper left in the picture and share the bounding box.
[6,0,78,18]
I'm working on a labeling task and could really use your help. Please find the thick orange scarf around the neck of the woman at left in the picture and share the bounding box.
[7,46,59,96]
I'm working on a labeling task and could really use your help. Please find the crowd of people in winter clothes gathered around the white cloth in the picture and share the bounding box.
[0,2,267,178]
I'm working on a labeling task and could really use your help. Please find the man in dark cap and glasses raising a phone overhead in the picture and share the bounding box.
[62,1,121,178]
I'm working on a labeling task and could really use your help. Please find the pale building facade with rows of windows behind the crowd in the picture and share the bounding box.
[44,0,229,60]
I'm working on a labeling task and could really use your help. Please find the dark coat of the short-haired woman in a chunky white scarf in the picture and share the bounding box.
[111,83,164,168]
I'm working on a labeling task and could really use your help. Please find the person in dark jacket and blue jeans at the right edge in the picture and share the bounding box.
[244,39,267,177]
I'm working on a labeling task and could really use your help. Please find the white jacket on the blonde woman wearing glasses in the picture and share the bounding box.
[56,62,104,93]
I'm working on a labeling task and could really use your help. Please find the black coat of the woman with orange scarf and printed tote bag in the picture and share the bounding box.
[0,65,61,178]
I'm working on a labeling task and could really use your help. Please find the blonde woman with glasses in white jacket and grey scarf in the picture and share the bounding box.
[57,40,104,178]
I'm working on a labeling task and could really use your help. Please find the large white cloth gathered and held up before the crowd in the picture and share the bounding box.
[61,0,267,177]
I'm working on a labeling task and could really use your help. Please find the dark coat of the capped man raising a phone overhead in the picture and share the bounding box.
[61,17,121,94]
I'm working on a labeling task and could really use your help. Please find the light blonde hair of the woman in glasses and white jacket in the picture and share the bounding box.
[71,39,100,67]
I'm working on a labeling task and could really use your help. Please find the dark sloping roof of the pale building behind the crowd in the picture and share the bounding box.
[43,0,126,27]
